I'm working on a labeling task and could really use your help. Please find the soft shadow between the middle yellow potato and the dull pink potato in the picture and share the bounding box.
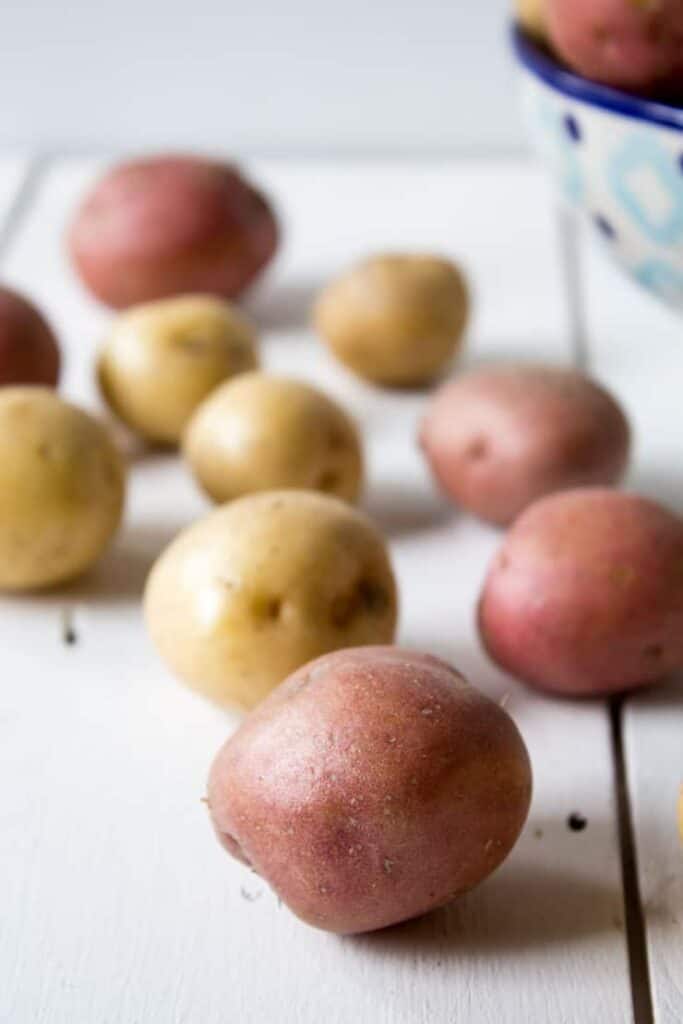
[362,480,458,538]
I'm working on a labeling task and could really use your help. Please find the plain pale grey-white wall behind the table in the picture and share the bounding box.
[0,0,522,155]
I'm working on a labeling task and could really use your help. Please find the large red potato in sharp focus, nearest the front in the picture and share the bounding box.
[208,647,531,933]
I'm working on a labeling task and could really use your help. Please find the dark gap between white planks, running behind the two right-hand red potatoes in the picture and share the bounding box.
[557,206,654,1024]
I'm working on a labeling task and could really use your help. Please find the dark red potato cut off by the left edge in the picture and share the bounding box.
[0,288,60,387]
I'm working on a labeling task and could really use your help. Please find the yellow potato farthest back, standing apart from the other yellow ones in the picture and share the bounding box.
[314,253,469,387]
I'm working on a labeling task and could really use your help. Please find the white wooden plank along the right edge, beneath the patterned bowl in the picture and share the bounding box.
[584,232,683,1024]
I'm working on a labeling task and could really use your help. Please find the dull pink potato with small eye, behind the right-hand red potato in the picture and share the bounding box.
[420,366,630,524]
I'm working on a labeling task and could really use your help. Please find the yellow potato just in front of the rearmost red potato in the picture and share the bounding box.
[97,295,258,444]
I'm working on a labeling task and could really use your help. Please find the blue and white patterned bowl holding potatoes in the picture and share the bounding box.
[513,28,683,313]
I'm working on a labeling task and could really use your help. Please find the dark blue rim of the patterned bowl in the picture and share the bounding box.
[512,25,683,132]
